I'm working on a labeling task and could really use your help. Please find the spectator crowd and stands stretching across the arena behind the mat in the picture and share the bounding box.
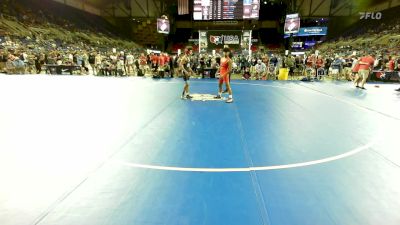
[0,0,400,88]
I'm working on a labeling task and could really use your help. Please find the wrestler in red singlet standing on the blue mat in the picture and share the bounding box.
[216,48,233,103]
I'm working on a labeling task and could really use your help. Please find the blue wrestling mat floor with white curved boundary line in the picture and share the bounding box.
[0,75,400,225]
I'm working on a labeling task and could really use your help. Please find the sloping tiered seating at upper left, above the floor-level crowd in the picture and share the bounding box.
[0,0,139,48]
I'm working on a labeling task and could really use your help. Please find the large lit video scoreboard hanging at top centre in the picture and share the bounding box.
[193,0,260,20]
